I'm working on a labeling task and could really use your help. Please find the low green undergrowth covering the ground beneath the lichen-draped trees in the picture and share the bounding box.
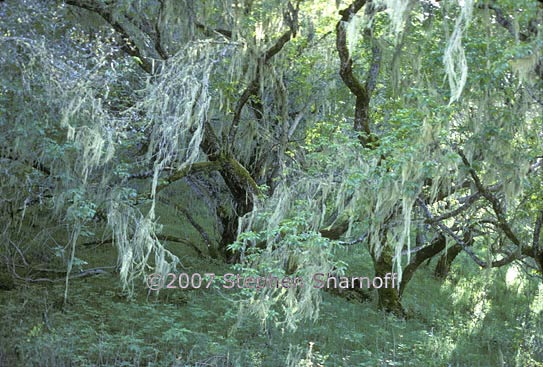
[0,251,543,367]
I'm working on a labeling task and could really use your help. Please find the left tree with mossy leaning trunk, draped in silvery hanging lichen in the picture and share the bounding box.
[3,1,316,294]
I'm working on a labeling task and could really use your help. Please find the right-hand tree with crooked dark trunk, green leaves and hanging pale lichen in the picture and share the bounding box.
[235,1,542,322]
